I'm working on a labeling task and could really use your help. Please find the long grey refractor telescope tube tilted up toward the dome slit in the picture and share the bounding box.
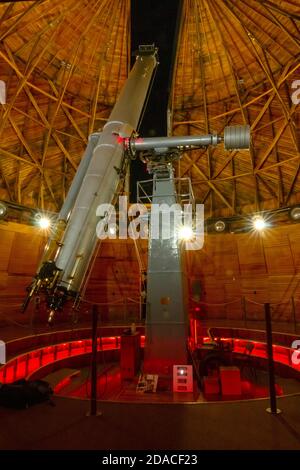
[22,46,158,311]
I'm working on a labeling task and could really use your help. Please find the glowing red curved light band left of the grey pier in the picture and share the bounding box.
[0,336,145,383]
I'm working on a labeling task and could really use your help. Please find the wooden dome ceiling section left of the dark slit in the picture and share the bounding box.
[0,0,130,210]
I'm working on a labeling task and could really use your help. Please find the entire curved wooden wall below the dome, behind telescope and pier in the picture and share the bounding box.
[0,223,300,321]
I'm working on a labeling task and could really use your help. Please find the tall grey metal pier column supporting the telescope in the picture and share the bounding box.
[144,165,188,377]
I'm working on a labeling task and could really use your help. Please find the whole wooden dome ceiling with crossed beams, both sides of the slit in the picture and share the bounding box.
[0,0,300,216]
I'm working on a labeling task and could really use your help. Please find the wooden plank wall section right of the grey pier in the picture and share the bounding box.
[187,224,300,321]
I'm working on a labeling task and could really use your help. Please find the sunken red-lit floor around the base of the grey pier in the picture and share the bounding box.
[48,363,300,403]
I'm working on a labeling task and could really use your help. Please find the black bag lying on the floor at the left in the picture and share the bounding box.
[0,379,53,409]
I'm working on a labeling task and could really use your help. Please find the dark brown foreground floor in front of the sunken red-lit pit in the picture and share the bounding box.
[0,394,300,450]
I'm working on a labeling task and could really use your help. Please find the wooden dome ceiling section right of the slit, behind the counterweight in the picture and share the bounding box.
[171,0,300,216]
